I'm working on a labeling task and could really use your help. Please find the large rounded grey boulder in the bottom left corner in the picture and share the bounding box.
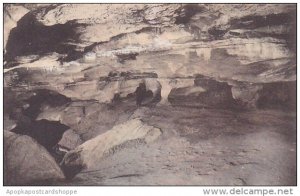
[4,131,64,185]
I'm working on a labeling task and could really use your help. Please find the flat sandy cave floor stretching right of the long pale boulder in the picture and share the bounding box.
[58,105,296,185]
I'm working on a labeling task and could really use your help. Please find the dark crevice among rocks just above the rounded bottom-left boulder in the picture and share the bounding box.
[6,89,71,161]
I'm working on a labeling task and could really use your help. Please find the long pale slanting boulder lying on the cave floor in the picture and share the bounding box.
[61,119,161,177]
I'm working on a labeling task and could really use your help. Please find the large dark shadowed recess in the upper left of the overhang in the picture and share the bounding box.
[5,12,82,64]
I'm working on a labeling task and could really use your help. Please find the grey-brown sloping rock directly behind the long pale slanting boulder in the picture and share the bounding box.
[37,101,136,141]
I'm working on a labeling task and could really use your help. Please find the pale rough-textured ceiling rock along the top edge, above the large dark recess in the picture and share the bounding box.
[37,4,180,43]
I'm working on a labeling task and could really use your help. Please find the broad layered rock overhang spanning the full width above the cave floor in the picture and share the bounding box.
[4,4,296,110]
